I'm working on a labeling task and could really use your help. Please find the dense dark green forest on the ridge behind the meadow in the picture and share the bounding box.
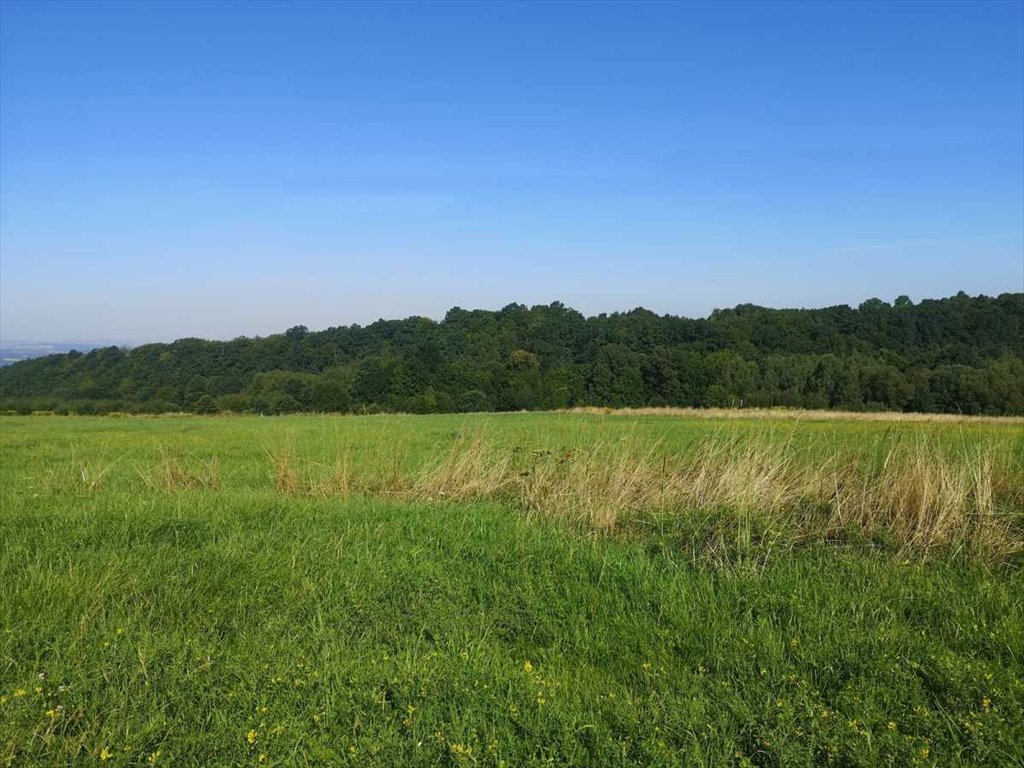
[0,293,1024,414]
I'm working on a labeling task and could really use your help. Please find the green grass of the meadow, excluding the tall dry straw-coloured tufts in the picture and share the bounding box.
[0,415,1024,766]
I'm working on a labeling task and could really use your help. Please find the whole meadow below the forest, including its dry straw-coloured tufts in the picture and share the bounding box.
[0,413,1024,768]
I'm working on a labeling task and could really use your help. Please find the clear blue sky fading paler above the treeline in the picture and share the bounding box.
[0,0,1024,342]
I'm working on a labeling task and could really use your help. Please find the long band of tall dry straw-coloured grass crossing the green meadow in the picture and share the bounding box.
[241,426,1024,561]
